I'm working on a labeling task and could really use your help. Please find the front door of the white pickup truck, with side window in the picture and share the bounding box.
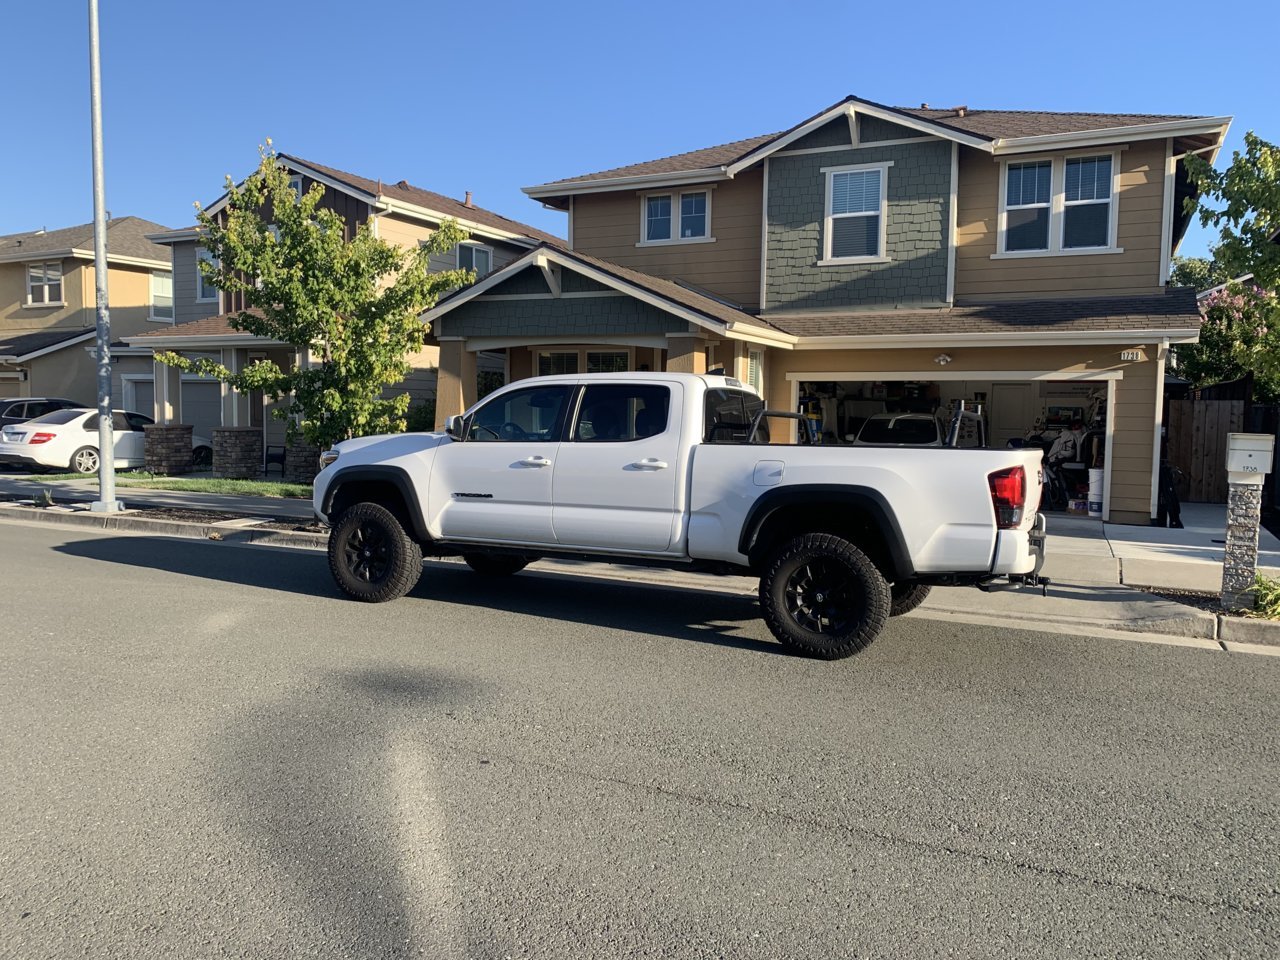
[428,384,576,544]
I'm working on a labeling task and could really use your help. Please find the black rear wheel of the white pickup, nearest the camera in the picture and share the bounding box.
[760,534,890,660]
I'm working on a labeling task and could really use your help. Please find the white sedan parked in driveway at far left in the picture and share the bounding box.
[0,407,214,474]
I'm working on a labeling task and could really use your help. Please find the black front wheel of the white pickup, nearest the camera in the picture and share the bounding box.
[329,503,422,603]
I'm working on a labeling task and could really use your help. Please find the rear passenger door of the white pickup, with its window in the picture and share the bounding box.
[552,383,684,552]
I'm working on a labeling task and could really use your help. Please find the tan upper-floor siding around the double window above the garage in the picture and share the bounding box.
[955,140,1166,301]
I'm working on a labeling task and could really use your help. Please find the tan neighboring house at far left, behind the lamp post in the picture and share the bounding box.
[0,216,174,406]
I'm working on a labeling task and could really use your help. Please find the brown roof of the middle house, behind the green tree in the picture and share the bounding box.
[199,154,564,246]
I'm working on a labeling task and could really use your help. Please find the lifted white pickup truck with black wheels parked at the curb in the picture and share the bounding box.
[315,372,1044,659]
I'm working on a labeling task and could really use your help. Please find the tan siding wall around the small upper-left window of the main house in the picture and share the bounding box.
[571,169,764,310]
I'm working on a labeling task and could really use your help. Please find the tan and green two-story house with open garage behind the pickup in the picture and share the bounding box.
[426,97,1230,522]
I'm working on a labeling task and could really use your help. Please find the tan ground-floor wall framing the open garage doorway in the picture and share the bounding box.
[764,343,1158,522]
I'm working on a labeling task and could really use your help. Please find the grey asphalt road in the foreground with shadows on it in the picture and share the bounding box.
[0,522,1280,960]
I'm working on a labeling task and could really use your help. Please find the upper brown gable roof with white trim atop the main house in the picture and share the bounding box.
[524,96,1230,205]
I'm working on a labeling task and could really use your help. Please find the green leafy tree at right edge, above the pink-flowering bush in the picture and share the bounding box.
[1187,131,1280,291]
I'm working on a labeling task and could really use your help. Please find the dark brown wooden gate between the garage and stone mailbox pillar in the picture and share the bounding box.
[1165,399,1244,503]
